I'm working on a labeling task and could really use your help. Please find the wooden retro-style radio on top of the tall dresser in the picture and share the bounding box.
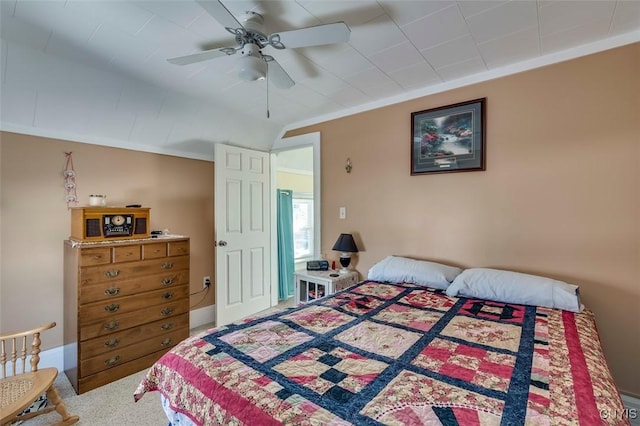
[69,207,150,241]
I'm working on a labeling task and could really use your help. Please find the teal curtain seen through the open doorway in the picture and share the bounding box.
[277,189,295,300]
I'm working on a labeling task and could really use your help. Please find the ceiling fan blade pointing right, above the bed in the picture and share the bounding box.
[269,22,351,49]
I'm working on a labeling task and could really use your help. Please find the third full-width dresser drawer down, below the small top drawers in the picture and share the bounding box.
[78,284,189,325]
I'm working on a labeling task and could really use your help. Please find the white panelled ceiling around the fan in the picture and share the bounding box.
[0,0,640,160]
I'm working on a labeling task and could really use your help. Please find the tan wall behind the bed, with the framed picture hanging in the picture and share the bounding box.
[286,44,640,397]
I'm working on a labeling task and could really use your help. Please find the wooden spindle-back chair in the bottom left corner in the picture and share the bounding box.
[0,322,79,426]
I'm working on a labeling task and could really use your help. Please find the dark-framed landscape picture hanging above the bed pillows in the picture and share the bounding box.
[411,98,487,175]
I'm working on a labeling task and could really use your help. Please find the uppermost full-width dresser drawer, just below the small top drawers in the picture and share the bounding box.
[80,256,189,286]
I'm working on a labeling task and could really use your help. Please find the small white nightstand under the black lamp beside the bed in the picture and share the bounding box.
[294,270,358,304]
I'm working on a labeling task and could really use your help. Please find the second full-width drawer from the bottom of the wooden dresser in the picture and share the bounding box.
[80,314,189,359]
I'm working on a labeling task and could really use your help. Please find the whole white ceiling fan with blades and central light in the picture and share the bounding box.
[167,0,350,89]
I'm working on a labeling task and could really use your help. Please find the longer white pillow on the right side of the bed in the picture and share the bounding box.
[446,268,584,312]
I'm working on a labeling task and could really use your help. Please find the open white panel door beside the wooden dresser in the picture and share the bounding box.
[214,144,271,326]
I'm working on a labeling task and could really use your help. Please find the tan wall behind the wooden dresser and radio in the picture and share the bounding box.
[0,132,215,348]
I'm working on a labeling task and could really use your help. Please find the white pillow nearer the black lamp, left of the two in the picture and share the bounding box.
[368,256,462,290]
